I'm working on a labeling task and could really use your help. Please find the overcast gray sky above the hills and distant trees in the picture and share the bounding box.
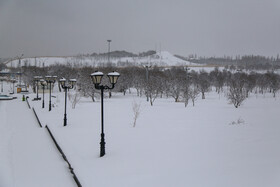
[0,0,280,58]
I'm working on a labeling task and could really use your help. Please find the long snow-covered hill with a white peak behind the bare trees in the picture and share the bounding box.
[6,51,198,67]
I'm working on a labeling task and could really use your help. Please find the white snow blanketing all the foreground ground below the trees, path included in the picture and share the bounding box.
[0,82,280,187]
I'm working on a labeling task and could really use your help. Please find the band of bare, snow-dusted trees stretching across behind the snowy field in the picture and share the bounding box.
[8,64,280,108]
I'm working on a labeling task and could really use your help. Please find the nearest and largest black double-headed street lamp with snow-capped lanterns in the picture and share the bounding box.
[90,71,120,157]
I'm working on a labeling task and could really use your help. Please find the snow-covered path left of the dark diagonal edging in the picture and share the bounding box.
[0,99,75,187]
